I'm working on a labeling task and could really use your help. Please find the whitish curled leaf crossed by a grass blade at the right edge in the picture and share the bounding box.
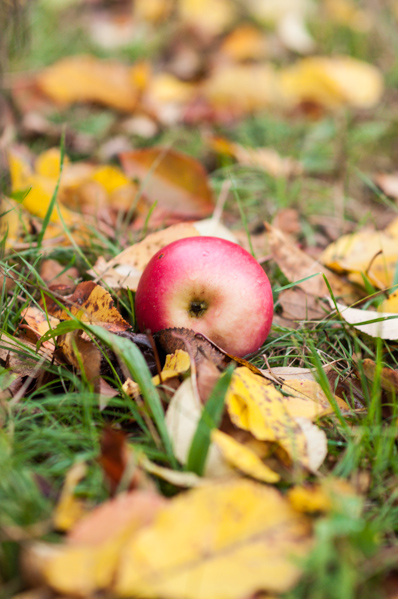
[330,302,398,340]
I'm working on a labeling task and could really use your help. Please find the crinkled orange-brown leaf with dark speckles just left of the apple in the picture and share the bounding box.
[46,281,131,333]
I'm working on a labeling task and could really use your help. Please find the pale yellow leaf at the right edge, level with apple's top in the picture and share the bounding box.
[320,231,398,289]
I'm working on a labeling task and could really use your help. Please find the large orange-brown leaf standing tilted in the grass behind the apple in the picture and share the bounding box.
[120,147,214,219]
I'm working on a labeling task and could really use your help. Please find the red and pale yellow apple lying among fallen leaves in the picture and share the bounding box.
[135,236,273,357]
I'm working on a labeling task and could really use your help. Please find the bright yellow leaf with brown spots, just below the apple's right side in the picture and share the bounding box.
[225,366,308,466]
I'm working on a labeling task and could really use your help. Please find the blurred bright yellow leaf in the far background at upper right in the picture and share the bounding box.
[280,56,383,108]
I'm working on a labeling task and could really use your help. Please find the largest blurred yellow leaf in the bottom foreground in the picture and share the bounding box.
[115,479,310,599]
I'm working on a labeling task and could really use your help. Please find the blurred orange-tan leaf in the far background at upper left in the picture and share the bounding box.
[36,55,139,112]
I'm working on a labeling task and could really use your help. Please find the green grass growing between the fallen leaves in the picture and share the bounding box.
[0,4,398,599]
